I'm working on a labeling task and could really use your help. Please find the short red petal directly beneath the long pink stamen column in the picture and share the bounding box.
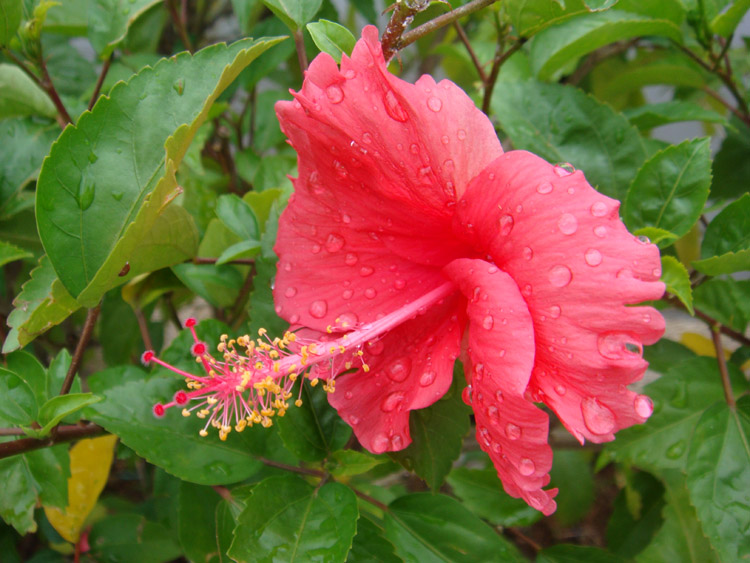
[328,294,465,453]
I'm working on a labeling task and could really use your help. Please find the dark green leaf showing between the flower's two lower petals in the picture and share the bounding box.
[388,374,471,491]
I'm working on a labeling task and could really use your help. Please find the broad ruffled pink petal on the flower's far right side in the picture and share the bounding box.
[454,151,664,442]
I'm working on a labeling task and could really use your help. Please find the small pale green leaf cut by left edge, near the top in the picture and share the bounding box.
[0,63,57,119]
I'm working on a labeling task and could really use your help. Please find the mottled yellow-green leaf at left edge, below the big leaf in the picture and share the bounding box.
[3,255,80,353]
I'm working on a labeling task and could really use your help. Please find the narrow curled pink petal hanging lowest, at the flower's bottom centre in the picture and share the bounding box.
[444,259,557,514]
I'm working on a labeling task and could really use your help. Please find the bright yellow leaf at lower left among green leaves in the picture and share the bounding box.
[44,436,117,543]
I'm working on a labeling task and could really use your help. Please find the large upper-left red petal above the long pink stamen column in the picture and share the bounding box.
[274,27,502,330]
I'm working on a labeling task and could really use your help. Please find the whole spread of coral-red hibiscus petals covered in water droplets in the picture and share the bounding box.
[274,27,664,514]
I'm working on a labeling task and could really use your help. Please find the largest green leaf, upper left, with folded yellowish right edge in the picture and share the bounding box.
[37,35,278,306]
